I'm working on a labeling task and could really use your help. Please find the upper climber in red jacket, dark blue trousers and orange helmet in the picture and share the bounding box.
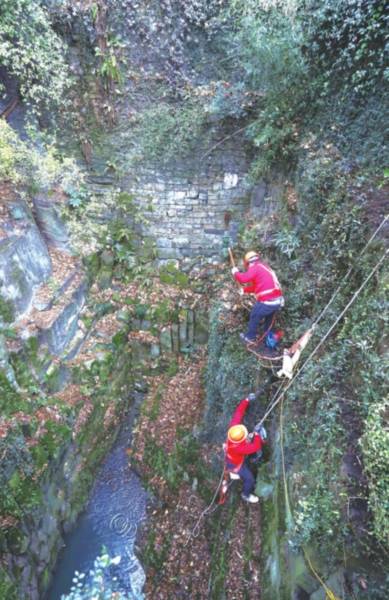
[231,251,284,343]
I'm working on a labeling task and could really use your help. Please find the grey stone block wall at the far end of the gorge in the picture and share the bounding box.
[122,150,250,261]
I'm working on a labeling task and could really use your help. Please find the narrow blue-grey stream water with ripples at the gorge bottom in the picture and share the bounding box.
[45,402,147,600]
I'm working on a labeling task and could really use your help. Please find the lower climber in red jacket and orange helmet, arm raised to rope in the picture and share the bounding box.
[224,394,266,503]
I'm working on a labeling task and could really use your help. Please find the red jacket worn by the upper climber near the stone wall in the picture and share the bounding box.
[234,261,282,302]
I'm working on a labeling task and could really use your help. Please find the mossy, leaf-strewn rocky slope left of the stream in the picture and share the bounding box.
[0,162,212,599]
